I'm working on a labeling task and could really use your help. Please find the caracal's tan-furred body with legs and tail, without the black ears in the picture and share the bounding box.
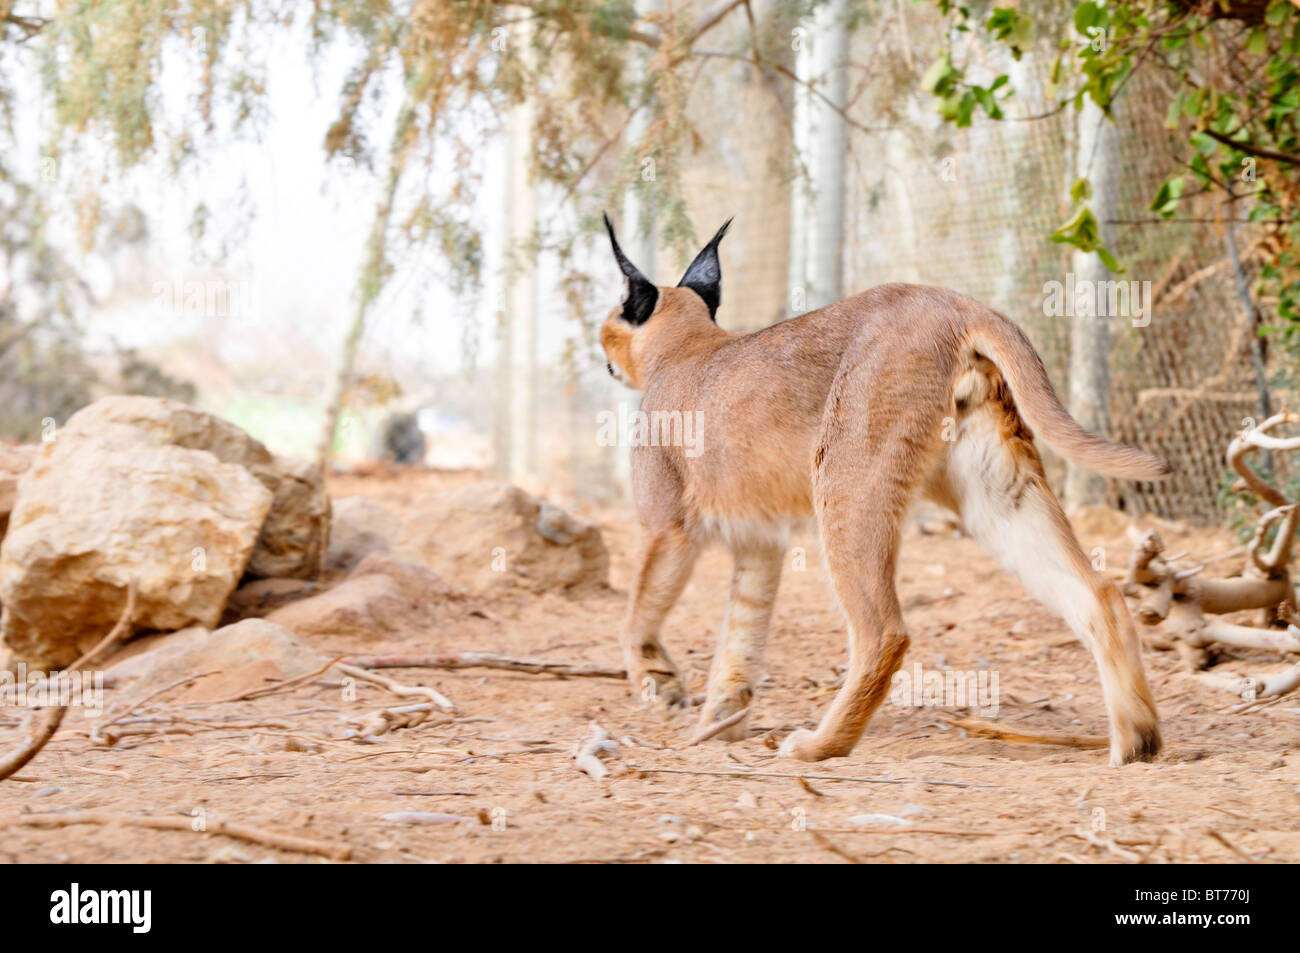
[601,278,1167,763]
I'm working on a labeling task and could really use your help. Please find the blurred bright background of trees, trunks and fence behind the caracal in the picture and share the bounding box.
[0,0,1300,523]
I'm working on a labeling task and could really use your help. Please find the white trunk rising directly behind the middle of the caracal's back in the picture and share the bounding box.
[789,0,849,313]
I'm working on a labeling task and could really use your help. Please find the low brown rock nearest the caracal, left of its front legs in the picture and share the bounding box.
[398,484,610,592]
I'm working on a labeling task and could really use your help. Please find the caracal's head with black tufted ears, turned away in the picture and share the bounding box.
[601,216,731,390]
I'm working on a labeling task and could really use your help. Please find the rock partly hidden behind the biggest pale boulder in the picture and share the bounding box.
[59,395,330,579]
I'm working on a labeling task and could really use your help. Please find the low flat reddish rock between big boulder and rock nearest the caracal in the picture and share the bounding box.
[267,553,471,642]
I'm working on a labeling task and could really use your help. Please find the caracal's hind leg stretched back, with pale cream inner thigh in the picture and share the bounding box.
[946,372,1161,764]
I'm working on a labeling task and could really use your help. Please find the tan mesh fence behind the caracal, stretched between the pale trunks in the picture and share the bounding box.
[418,3,1265,523]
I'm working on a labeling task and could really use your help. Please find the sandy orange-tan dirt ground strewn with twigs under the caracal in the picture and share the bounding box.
[0,473,1300,863]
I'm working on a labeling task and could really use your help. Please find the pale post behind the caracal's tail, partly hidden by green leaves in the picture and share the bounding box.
[1065,100,1119,510]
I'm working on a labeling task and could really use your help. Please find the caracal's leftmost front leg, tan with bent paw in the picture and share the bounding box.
[620,527,699,707]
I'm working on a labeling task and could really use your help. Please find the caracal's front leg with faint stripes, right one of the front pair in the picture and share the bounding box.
[699,546,785,741]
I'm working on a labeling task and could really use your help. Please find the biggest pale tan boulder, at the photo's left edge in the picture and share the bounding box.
[0,426,272,667]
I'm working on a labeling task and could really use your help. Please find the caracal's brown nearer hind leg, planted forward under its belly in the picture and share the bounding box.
[781,379,940,761]
